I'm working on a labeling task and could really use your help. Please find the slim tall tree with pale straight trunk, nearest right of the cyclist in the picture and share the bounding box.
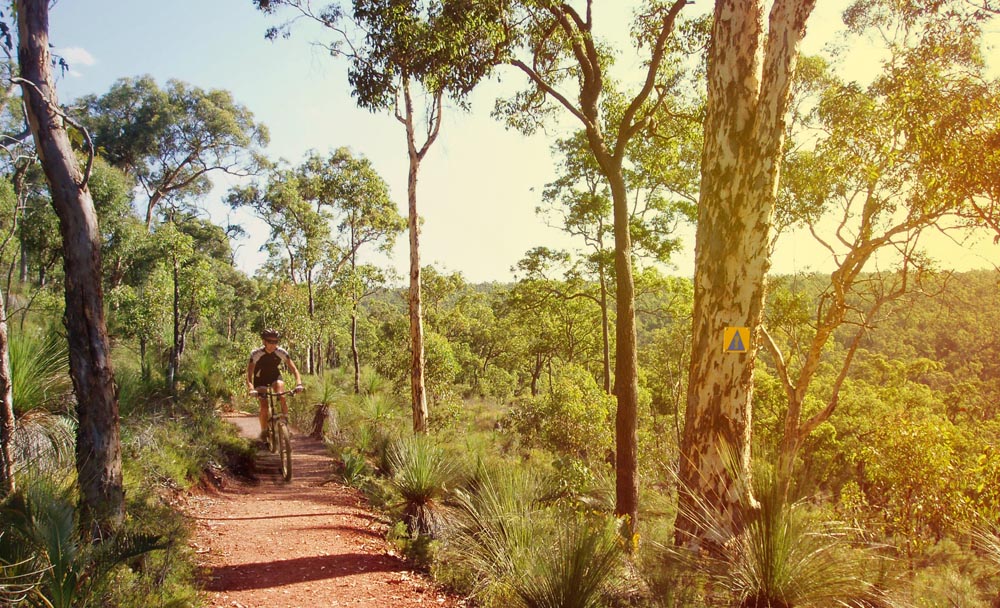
[254,0,503,433]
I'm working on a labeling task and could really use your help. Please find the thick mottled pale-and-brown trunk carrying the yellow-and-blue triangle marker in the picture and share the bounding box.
[676,0,815,544]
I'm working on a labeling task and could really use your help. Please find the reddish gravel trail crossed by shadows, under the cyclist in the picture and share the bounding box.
[185,415,464,608]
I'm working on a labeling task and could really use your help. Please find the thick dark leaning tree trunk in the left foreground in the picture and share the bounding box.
[16,0,125,539]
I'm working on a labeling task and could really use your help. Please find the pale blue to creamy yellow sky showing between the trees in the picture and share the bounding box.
[50,0,1000,282]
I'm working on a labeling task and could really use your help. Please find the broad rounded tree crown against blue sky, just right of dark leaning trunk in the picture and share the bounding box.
[76,76,268,231]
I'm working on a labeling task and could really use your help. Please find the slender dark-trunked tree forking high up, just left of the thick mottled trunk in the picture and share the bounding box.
[497,0,700,531]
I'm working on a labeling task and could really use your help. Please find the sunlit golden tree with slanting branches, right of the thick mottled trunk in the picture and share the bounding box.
[761,3,1000,498]
